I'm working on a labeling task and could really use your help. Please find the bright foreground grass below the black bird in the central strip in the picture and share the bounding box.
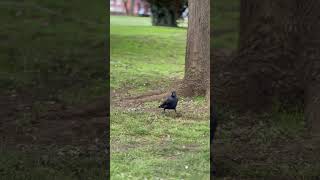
[111,107,210,179]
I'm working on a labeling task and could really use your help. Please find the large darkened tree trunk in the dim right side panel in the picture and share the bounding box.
[231,0,320,136]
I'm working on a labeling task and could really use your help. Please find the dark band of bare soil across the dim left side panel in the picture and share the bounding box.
[0,91,108,150]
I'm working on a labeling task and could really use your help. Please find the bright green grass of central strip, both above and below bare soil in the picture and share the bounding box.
[111,16,209,179]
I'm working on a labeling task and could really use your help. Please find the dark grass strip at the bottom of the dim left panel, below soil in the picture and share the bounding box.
[0,147,106,180]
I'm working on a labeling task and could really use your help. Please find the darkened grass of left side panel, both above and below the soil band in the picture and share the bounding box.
[0,0,108,180]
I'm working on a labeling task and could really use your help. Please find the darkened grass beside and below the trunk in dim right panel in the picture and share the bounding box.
[211,0,320,179]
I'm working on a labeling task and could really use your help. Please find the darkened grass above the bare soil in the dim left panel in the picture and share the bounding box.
[0,0,107,104]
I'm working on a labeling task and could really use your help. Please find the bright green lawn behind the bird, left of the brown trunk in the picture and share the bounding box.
[110,16,186,95]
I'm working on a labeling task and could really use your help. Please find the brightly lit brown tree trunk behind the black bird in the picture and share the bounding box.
[184,0,210,97]
